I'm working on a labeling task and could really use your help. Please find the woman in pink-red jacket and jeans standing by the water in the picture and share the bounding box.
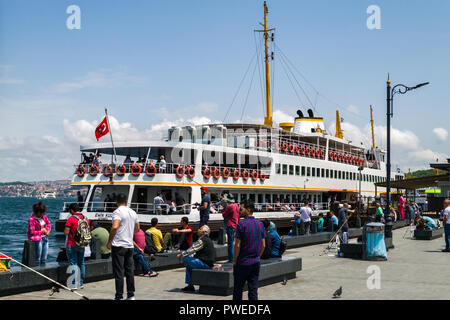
[27,202,51,266]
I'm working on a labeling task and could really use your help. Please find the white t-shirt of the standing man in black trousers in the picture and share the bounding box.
[112,206,138,249]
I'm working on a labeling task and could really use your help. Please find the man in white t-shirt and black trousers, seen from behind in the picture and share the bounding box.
[107,193,141,300]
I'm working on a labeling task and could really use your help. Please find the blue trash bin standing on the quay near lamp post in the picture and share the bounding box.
[363,222,387,260]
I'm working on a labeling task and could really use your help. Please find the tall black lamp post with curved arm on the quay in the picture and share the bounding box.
[384,75,429,220]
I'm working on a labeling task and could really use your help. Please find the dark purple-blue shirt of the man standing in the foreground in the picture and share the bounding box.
[236,216,265,266]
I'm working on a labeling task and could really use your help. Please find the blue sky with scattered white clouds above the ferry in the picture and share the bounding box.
[0,0,450,181]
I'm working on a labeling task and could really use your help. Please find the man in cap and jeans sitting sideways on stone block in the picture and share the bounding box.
[177,225,216,292]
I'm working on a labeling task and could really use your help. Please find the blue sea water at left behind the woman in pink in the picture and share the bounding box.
[0,197,71,262]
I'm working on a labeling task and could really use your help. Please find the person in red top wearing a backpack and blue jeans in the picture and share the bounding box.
[64,203,92,289]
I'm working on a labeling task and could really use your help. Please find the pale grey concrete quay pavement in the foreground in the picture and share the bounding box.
[0,228,450,300]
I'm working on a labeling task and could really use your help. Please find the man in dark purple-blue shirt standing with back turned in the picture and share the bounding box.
[233,200,266,301]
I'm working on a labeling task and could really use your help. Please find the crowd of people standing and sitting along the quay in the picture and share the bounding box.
[28,194,450,301]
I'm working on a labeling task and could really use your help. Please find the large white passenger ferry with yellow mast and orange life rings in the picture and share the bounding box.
[56,3,399,232]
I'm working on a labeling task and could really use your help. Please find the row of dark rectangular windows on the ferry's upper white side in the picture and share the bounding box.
[275,163,388,183]
